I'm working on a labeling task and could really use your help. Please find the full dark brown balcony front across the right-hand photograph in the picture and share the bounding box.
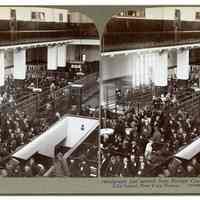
[102,18,200,52]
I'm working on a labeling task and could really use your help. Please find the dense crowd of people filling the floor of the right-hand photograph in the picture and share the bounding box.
[101,87,200,177]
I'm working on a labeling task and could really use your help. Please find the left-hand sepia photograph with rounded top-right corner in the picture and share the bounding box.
[0,6,100,177]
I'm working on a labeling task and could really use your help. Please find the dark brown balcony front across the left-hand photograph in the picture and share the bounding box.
[0,21,98,46]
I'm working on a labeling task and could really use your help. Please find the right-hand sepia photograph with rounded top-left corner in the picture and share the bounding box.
[100,6,200,177]
